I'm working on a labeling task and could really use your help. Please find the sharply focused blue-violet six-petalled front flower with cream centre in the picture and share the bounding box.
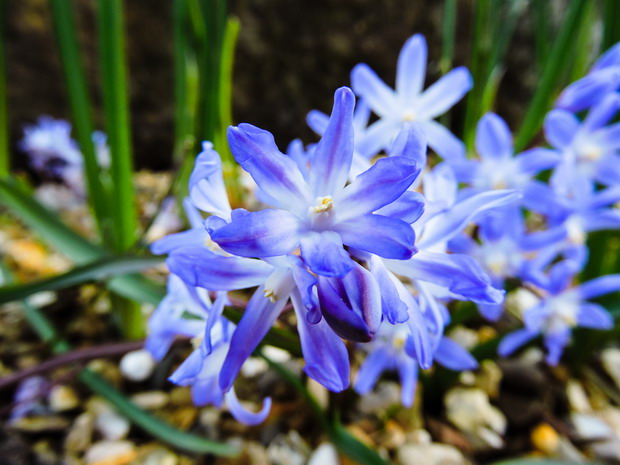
[207,88,419,276]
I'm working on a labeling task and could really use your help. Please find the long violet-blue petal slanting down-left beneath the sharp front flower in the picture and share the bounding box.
[220,286,288,391]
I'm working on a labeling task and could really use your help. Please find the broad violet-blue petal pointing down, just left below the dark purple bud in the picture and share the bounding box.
[291,291,349,392]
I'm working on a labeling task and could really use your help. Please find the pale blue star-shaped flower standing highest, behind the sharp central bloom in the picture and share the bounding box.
[351,34,473,159]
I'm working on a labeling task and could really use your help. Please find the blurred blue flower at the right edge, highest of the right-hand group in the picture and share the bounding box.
[555,44,620,113]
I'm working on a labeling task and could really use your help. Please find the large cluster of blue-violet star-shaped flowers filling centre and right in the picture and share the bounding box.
[147,35,620,424]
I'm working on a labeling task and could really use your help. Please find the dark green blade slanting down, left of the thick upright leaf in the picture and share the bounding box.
[49,0,113,244]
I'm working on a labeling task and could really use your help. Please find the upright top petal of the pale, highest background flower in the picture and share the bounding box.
[396,34,428,104]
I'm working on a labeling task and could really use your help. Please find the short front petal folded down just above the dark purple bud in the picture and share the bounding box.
[300,231,353,276]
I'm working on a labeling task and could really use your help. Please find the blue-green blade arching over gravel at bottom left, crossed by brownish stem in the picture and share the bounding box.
[2,260,239,457]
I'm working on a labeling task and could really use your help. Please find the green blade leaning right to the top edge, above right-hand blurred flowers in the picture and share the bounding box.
[515,0,586,152]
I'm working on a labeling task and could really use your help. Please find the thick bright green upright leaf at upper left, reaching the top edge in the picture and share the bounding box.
[97,0,138,252]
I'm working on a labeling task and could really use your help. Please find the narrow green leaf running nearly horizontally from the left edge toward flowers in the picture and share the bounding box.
[0,257,163,304]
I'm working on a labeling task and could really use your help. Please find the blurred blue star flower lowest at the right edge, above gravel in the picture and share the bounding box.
[498,270,620,365]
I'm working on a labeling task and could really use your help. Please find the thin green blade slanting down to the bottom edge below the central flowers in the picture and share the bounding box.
[259,351,388,465]
